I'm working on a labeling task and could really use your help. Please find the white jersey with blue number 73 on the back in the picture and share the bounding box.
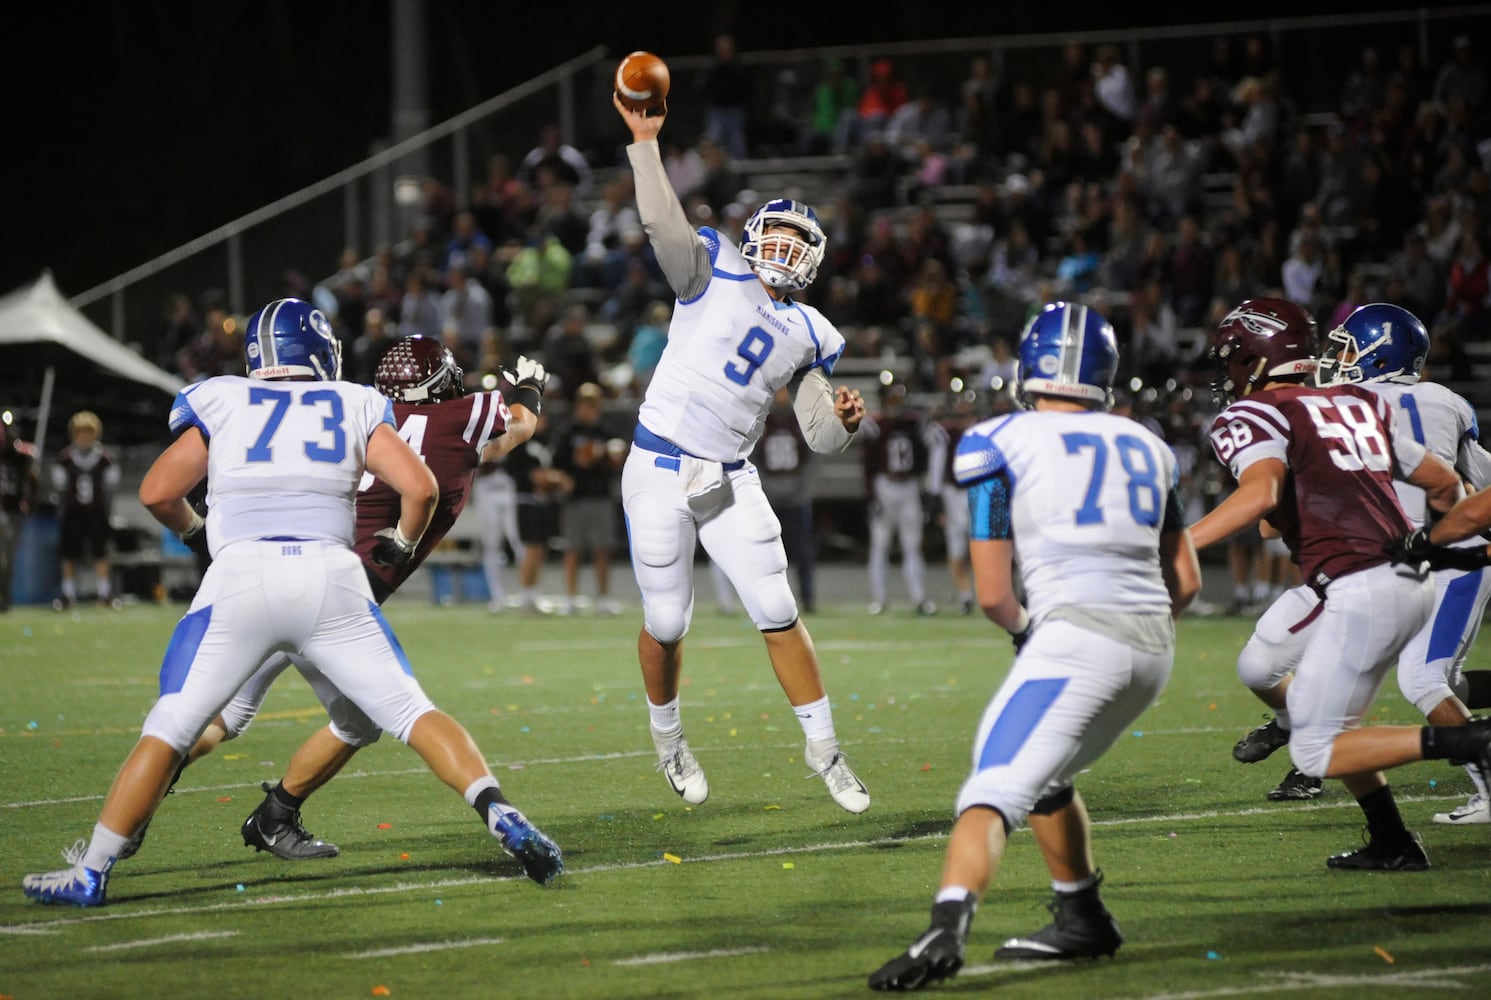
[170,376,395,556]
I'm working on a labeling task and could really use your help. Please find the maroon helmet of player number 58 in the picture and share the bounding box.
[1211,298,1317,407]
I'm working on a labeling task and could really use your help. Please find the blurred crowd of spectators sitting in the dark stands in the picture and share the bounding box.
[145,27,1491,530]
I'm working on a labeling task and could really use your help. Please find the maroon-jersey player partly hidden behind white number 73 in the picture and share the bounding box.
[131,337,547,860]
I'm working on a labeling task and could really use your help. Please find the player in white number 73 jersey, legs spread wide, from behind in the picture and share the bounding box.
[22,300,564,906]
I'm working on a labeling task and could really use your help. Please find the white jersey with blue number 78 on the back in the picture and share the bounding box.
[953,410,1179,621]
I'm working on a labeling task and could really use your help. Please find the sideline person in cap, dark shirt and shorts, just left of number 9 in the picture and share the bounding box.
[552,382,626,614]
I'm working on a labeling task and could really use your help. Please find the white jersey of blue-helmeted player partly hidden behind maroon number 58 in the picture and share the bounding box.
[1361,382,1491,527]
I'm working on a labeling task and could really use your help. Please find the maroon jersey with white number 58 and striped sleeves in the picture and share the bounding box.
[1211,386,1424,590]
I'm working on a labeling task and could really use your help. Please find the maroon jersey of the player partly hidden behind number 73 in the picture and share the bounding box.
[355,392,510,602]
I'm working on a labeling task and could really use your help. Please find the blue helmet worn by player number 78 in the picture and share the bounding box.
[1018,303,1118,410]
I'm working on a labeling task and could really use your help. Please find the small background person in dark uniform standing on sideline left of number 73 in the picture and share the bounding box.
[52,410,119,611]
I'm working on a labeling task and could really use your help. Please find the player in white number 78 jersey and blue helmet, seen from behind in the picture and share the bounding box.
[869,303,1200,990]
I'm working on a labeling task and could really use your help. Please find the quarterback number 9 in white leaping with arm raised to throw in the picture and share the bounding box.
[611,87,869,812]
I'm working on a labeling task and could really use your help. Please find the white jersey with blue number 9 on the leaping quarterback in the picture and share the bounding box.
[638,228,844,462]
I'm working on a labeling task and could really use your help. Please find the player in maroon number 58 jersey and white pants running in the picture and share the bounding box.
[1191,298,1491,870]
